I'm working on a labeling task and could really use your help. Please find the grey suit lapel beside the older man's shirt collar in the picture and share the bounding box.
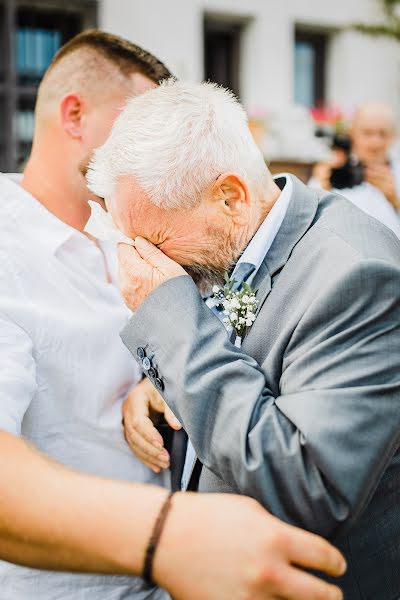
[253,175,318,316]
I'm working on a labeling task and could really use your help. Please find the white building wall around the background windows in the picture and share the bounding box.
[100,0,400,118]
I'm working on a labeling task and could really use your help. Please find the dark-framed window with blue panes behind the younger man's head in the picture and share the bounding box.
[0,0,96,172]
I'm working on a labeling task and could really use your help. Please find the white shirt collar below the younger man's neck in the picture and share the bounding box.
[0,173,86,254]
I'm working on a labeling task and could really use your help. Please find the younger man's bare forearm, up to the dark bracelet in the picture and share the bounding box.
[0,432,166,574]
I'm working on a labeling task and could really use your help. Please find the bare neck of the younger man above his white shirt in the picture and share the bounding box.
[21,154,90,231]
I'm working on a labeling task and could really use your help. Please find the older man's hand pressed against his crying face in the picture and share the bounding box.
[118,237,187,312]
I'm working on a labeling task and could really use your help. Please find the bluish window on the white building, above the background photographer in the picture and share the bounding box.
[294,30,327,108]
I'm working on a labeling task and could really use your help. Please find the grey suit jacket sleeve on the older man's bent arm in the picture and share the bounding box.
[122,260,400,537]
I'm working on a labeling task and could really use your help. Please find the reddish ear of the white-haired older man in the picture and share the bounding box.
[211,173,250,223]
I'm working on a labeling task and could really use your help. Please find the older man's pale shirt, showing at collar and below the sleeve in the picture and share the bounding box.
[181,173,293,491]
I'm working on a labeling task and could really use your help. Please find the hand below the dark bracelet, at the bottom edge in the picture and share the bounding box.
[154,492,345,600]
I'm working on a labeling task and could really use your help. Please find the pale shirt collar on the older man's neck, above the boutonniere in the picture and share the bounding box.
[232,173,293,283]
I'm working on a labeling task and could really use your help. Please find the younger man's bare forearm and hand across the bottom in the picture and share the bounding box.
[0,431,346,600]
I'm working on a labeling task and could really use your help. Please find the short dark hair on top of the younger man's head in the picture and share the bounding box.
[49,29,172,83]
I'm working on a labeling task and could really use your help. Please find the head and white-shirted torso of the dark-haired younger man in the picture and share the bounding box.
[0,31,170,600]
